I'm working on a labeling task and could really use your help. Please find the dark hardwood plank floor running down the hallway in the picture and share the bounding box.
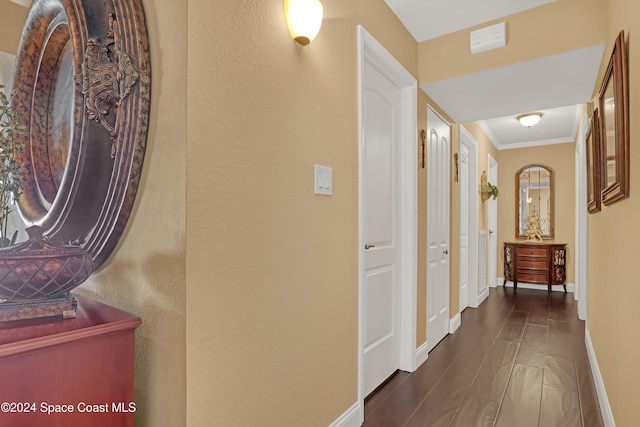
[364,287,603,427]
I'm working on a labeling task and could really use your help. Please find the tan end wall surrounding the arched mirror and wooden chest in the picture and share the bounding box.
[497,143,576,289]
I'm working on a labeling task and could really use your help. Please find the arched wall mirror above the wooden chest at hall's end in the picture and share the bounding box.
[516,165,555,239]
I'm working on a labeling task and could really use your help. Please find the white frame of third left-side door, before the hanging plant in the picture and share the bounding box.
[458,125,482,308]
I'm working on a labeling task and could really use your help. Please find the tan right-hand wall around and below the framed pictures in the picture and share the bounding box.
[587,0,640,427]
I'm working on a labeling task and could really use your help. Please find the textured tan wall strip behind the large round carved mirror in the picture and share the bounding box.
[79,0,187,427]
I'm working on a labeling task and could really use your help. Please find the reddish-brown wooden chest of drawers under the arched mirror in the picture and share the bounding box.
[503,242,567,292]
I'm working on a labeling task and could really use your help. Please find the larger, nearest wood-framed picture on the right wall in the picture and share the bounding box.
[599,31,629,205]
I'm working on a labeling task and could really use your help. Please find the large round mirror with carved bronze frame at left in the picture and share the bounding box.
[13,0,151,270]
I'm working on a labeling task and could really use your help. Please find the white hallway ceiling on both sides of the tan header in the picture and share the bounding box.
[385,0,605,149]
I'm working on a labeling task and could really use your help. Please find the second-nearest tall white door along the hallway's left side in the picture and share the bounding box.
[427,108,451,351]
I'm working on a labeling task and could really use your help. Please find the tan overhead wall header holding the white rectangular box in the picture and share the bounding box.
[419,0,606,85]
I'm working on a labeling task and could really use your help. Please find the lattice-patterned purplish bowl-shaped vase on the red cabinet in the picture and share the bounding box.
[0,226,93,304]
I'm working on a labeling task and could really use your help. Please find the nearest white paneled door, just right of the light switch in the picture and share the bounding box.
[363,59,400,395]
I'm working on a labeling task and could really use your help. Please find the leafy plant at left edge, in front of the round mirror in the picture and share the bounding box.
[0,84,27,247]
